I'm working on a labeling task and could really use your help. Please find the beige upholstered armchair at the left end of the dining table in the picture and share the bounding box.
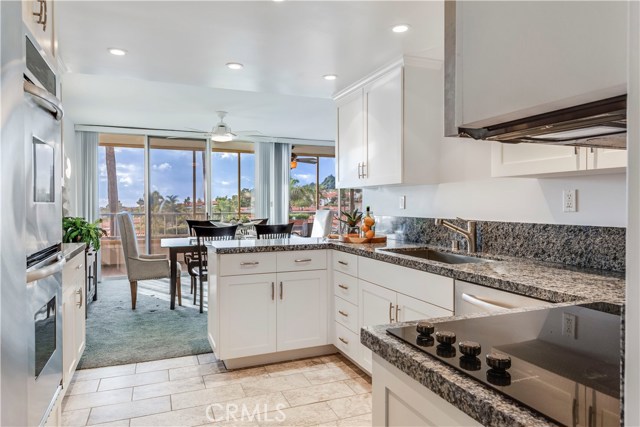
[116,212,182,310]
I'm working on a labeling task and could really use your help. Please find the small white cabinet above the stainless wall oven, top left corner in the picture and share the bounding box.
[22,0,57,60]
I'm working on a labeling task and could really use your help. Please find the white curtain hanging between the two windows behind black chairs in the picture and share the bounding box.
[255,142,291,224]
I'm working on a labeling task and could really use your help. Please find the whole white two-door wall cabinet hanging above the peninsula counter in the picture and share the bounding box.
[334,57,443,188]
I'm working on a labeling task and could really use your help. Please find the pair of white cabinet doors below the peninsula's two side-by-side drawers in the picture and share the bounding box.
[217,270,328,360]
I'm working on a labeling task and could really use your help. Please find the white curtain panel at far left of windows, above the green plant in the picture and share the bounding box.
[76,131,99,221]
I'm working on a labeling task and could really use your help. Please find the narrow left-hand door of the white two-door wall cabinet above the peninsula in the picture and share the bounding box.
[336,89,364,188]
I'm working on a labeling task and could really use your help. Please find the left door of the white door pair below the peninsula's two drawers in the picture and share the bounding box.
[218,274,276,359]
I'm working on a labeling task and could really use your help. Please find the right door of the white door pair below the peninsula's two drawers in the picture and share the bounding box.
[276,270,329,351]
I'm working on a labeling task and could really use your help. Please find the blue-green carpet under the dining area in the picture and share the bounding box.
[78,278,211,369]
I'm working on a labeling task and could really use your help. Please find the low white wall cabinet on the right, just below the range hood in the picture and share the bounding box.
[491,142,627,177]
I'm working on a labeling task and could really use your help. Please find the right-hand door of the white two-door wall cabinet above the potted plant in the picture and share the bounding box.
[364,67,403,185]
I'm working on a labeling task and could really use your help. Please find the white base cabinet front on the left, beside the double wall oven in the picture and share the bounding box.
[62,251,86,389]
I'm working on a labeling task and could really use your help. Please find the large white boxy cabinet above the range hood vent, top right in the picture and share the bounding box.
[445,1,628,132]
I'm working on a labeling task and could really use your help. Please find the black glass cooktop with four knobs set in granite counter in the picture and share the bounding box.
[387,306,620,426]
